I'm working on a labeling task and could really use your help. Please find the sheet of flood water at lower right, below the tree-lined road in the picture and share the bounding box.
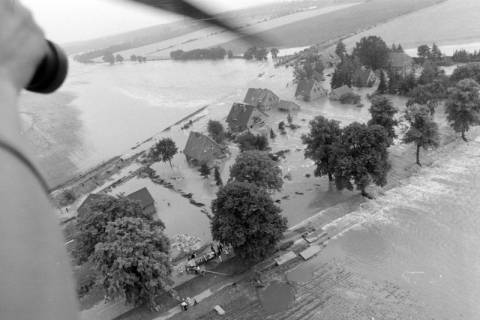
[288,136,480,320]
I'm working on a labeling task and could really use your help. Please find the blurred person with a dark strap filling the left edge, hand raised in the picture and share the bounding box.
[0,0,78,320]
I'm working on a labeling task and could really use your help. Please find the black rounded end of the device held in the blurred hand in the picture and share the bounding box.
[25,40,68,93]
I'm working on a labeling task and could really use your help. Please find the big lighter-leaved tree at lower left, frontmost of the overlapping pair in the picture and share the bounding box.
[92,217,173,309]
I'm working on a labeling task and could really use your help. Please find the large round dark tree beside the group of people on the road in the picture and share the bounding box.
[211,182,287,262]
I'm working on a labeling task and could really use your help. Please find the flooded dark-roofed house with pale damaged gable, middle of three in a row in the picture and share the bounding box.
[227,103,268,132]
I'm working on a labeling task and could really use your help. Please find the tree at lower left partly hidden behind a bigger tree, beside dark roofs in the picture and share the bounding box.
[74,194,159,263]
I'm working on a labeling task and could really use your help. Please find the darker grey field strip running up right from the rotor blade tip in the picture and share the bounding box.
[221,0,445,53]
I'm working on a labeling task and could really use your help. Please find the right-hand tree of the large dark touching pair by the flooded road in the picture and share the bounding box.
[334,122,391,197]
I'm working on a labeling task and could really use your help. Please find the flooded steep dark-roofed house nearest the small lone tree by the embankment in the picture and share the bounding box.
[183,131,226,165]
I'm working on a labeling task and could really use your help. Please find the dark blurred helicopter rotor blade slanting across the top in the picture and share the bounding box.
[126,0,269,45]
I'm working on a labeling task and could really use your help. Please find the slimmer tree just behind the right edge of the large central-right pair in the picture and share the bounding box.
[368,96,398,145]
